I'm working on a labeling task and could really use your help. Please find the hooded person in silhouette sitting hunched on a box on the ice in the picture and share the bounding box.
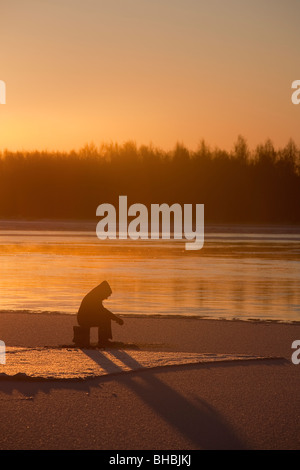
[77,281,124,347]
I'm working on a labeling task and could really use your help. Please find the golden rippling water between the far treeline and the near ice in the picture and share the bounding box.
[0,223,300,321]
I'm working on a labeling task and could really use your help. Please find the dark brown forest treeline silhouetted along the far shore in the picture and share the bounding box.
[0,136,300,223]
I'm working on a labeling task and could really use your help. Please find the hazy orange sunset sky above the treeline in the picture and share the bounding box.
[0,0,300,151]
